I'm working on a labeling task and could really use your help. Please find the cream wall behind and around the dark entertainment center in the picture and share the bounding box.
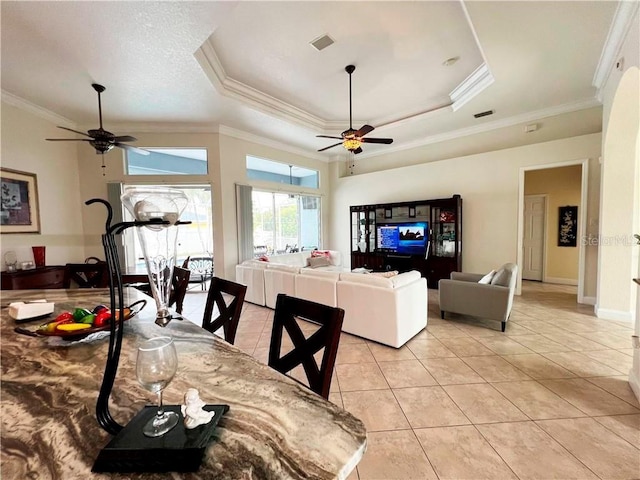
[330,134,601,295]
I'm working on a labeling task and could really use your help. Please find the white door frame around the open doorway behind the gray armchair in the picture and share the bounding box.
[516,158,597,303]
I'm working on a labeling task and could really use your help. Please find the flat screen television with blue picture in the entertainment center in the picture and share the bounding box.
[376,222,429,256]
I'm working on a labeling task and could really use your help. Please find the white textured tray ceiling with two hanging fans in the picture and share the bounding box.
[1,1,618,163]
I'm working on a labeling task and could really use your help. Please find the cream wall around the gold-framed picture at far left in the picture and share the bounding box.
[0,102,86,270]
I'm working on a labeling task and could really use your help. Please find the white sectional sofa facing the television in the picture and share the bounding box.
[236,251,427,348]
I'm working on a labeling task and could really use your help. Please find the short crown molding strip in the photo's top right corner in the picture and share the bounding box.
[592,0,638,100]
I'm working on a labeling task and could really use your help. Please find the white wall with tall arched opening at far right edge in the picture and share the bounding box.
[596,4,640,321]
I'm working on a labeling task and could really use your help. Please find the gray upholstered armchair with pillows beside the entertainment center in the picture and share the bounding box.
[438,263,518,332]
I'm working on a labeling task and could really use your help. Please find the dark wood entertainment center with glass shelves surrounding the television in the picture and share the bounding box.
[350,195,462,288]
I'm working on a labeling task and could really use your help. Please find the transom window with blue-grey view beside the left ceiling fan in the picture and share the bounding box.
[125,148,208,175]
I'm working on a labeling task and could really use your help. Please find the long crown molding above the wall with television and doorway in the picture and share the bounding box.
[358,98,602,159]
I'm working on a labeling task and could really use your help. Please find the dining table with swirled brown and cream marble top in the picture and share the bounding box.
[0,287,367,480]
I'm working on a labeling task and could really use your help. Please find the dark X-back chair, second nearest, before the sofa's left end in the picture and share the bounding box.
[202,277,247,344]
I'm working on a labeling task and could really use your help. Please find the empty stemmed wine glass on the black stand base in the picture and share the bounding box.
[136,337,178,437]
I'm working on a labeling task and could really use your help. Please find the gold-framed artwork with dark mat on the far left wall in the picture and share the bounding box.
[0,168,40,233]
